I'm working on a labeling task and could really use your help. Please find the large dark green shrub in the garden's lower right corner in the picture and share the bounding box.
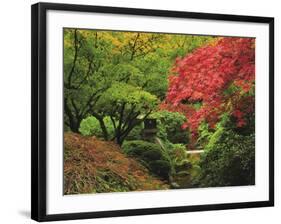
[196,130,255,187]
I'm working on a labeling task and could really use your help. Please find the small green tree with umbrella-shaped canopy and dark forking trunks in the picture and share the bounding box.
[97,83,159,145]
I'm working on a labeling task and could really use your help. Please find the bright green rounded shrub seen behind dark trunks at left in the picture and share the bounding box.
[79,116,114,138]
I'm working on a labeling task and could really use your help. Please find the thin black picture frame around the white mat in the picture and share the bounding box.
[31,3,274,221]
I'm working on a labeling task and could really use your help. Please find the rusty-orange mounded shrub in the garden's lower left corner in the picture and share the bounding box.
[64,133,169,194]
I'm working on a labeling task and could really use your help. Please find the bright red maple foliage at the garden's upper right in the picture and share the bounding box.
[162,37,255,131]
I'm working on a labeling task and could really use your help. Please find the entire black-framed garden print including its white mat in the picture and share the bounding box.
[31,3,274,221]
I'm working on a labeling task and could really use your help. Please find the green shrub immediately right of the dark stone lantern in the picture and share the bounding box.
[151,110,189,144]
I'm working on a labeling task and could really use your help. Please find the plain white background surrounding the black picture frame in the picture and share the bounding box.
[0,0,281,224]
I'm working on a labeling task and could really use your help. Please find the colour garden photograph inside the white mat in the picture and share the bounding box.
[63,28,255,195]
